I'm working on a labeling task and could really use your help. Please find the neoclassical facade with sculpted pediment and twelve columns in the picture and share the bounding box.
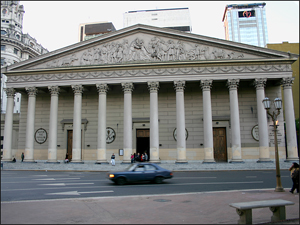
[2,24,299,164]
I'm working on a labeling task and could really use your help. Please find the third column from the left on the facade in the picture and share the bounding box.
[47,86,59,163]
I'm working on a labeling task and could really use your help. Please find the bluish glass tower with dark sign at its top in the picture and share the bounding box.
[222,3,268,47]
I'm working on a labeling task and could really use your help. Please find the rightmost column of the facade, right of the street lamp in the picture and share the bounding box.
[281,77,299,161]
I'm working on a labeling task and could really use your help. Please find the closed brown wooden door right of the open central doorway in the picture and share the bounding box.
[213,127,227,162]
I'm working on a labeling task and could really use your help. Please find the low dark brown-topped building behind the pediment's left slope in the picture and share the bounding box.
[78,22,116,41]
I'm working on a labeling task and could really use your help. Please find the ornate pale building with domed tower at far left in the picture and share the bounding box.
[1,1,49,113]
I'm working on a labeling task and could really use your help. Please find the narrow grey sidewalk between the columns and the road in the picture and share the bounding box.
[3,160,292,172]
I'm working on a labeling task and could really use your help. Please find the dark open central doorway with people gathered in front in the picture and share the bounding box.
[136,129,150,160]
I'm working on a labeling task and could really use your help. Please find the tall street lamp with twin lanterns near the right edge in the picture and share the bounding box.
[263,98,284,192]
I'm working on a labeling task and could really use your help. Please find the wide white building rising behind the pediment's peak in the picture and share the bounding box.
[123,8,192,33]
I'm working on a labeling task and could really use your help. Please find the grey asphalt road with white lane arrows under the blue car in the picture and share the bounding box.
[1,170,292,202]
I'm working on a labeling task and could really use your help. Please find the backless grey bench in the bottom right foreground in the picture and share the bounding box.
[229,199,295,224]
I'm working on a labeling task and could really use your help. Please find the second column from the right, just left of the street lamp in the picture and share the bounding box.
[254,78,272,163]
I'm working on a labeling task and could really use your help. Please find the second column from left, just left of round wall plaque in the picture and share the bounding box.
[23,87,38,163]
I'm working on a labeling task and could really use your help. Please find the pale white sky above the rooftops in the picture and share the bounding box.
[20,1,299,51]
